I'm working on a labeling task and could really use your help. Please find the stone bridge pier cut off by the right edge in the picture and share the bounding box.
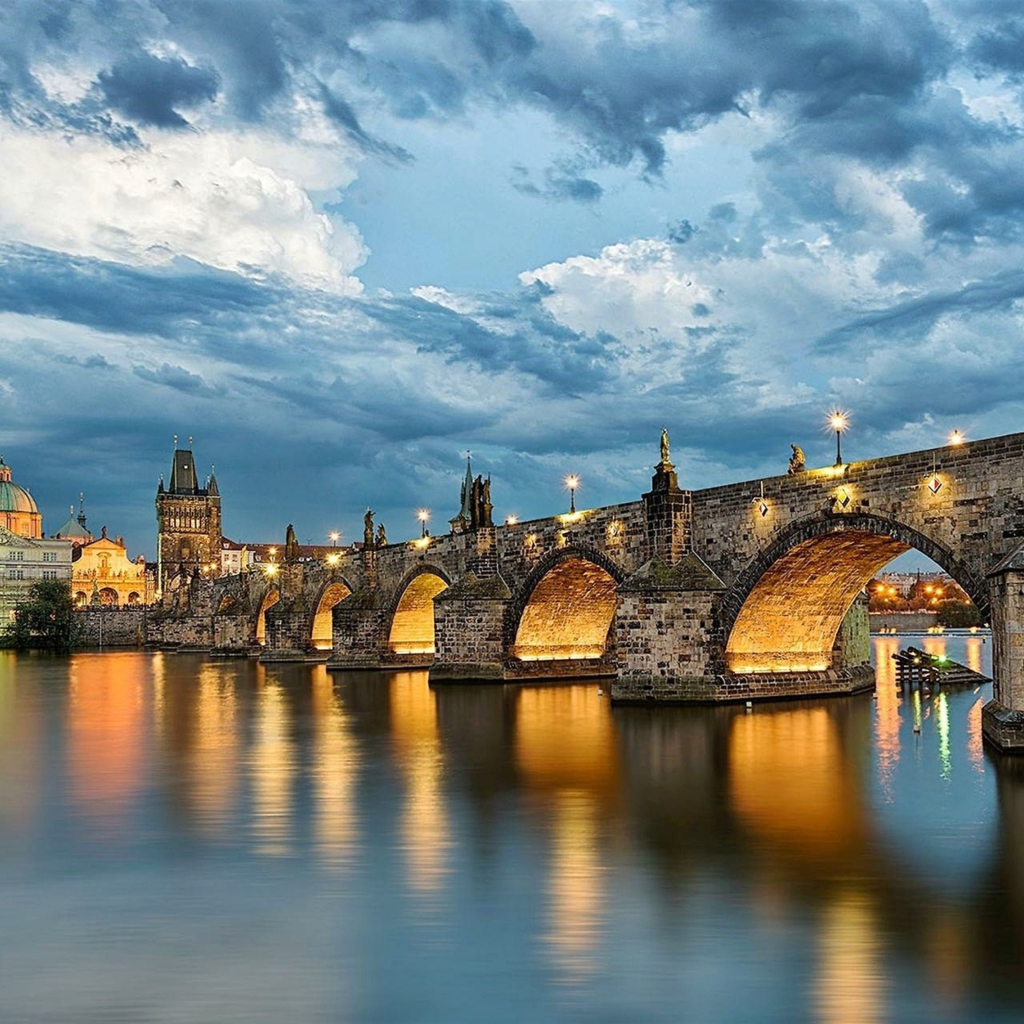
[981,546,1024,754]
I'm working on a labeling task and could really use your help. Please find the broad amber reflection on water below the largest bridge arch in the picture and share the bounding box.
[729,708,866,858]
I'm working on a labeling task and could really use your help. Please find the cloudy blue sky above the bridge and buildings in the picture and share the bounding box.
[0,0,1024,555]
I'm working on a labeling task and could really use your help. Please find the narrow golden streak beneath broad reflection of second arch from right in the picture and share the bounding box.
[544,791,605,984]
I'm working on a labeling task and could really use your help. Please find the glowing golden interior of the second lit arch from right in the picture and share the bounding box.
[512,558,617,662]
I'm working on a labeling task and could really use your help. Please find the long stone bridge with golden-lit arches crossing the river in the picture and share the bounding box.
[151,434,1024,748]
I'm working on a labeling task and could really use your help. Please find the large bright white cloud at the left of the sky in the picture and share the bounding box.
[0,126,367,295]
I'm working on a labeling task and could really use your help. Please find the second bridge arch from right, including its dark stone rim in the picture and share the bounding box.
[504,545,625,662]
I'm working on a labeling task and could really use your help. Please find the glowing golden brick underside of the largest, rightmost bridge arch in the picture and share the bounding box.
[726,530,908,673]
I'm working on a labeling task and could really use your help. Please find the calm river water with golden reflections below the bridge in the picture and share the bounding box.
[0,635,1024,1024]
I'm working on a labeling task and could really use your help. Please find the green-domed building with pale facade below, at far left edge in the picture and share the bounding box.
[0,457,72,627]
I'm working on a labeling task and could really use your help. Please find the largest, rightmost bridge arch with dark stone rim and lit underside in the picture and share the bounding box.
[720,513,988,673]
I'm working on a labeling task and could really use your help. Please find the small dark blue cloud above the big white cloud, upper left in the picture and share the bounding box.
[97,53,220,128]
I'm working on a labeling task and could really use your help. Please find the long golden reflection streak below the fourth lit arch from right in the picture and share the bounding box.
[311,665,359,870]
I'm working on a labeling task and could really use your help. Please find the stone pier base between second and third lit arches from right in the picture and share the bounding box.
[430,572,512,682]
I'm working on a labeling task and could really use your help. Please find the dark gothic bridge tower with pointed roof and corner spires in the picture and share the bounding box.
[157,437,222,593]
